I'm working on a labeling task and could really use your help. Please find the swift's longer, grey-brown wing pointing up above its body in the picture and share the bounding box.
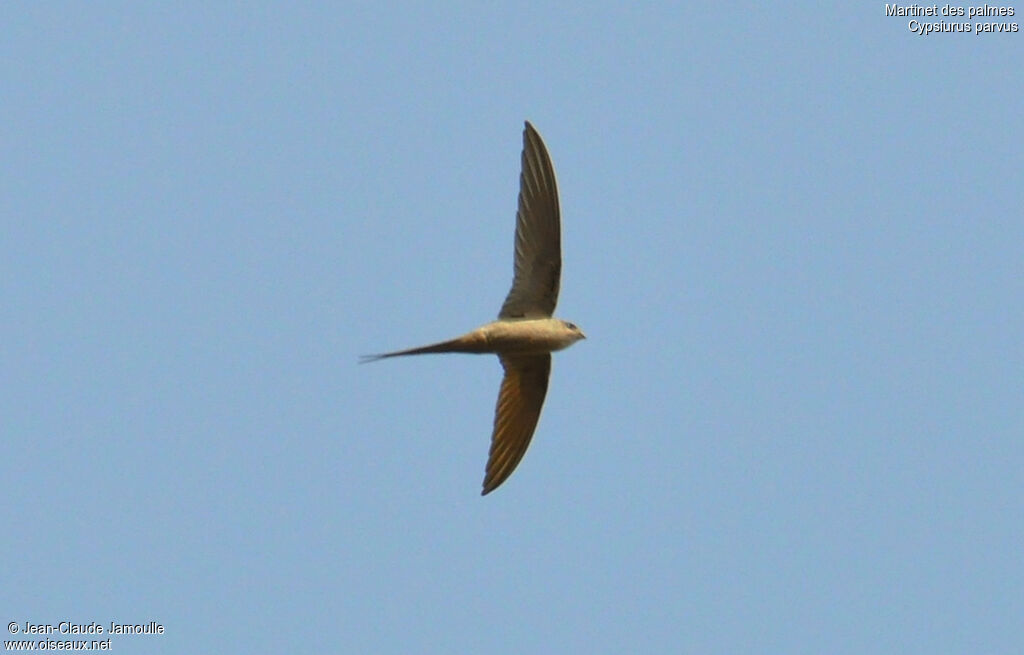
[498,121,562,318]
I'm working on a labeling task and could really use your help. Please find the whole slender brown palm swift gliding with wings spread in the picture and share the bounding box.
[364,121,586,495]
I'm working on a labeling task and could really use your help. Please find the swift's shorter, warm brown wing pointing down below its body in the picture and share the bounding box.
[483,354,551,495]
